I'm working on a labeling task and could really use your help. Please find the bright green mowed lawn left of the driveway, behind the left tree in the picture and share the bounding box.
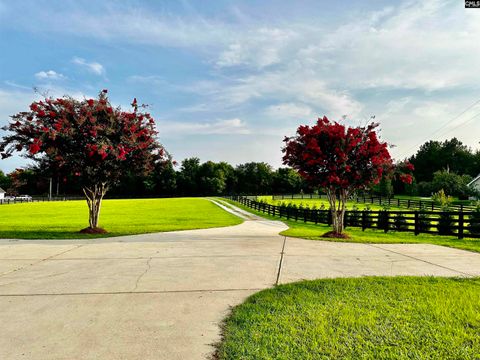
[0,198,242,239]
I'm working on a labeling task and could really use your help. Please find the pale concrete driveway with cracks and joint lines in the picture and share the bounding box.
[0,201,480,360]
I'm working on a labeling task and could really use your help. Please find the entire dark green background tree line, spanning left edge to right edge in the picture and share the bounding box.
[0,138,480,198]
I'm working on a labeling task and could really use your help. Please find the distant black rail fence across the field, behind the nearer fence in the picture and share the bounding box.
[272,194,476,211]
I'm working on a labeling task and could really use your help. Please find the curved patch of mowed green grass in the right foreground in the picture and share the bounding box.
[217,277,480,360]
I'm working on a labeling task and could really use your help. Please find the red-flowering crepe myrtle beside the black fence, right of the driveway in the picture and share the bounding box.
[282,117,412,236]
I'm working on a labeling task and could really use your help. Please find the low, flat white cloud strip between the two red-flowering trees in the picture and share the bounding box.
[159,118,250,136]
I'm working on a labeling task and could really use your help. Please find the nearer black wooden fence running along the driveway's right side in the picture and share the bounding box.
[227,196,480,239]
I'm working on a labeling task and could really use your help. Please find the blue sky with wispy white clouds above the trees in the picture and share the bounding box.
[0,0,480,172]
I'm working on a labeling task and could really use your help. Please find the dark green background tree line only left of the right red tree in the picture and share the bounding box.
[0,157,313,197]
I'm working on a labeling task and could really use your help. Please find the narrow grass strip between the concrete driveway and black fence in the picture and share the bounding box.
[223,200,480,252]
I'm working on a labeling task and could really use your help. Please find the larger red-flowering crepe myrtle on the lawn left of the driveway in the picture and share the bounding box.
[0,90,170,232]
